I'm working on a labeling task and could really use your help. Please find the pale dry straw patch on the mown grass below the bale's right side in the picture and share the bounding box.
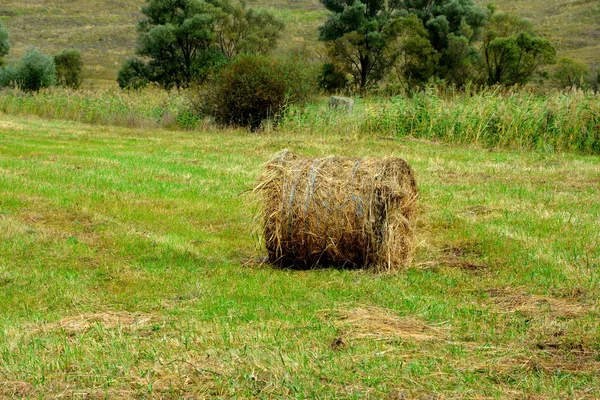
[336,307,443,341]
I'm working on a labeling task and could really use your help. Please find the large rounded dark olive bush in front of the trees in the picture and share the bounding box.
[204,55,315,130]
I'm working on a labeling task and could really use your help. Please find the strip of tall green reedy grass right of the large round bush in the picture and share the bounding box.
[280,89,600,154]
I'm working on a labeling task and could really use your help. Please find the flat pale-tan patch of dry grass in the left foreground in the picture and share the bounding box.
[42,312,152,335]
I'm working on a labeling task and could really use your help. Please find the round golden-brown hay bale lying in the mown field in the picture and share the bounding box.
[255,150,417,270]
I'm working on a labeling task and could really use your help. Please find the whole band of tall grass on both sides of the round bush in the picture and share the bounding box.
[0,89,600,154]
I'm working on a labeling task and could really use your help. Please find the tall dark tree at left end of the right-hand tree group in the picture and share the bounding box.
[319,0,422,91]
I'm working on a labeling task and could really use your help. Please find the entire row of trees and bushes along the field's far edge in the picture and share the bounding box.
[0,0,600,127]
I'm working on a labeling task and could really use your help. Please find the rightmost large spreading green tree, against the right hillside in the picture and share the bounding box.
[482,14,556,85]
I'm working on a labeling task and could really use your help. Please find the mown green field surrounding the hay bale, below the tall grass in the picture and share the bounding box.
[0,114,600,399]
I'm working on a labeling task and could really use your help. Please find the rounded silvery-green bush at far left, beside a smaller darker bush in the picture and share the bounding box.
[18,48,56,92]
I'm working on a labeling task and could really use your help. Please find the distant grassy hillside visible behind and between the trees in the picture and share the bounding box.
[0,0,600,86]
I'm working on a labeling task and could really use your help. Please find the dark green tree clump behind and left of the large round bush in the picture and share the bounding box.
[130,0,283,88]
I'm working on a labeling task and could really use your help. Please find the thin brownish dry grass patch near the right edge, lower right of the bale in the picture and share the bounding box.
[488,289,585,317]
